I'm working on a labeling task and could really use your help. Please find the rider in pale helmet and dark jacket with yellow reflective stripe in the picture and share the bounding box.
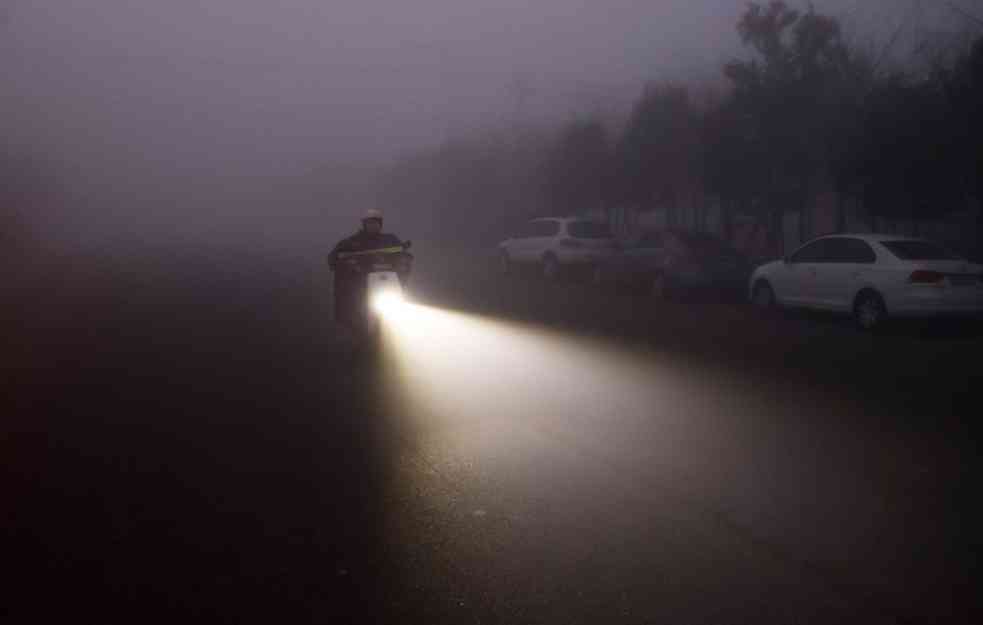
[328,208,408,325]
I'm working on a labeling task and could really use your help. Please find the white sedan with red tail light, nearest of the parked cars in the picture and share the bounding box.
[749,234,983,329]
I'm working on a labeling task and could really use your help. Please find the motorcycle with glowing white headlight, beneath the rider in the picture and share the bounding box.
[338,241,413,337]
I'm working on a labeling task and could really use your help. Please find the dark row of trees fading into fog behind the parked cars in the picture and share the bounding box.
[372,1,983,248]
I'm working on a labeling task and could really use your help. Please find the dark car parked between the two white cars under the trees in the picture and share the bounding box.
[594,230,753,298]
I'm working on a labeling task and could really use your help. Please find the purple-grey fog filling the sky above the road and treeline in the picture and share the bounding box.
[0,0,983,254]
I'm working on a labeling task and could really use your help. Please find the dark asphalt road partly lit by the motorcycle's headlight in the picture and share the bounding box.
[0,245,983,624]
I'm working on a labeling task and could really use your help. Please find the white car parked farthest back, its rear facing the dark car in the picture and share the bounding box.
[498,217,615,279]
